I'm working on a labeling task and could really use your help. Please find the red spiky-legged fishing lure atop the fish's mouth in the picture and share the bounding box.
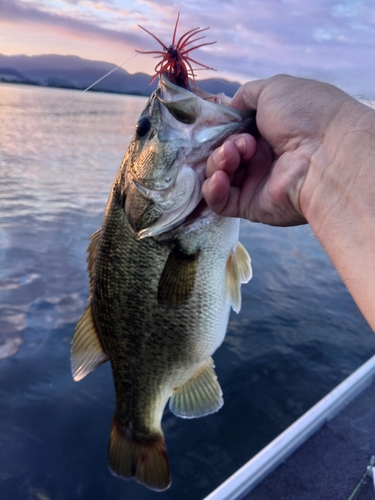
[136,13,216,90]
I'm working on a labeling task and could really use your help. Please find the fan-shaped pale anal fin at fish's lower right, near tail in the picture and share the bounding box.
[169,358,224,418]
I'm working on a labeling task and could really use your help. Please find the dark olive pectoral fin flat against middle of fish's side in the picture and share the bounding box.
[158,244,199,306]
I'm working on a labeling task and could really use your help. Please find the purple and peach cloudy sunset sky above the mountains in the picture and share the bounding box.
[0,0,375,100]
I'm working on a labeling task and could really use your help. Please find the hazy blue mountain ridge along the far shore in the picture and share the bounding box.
[0,54,239,96]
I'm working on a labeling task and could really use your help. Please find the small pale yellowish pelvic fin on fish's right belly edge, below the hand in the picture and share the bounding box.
[227,242,252,313]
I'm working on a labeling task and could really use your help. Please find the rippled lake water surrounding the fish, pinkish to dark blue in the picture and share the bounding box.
[0,84,375,500]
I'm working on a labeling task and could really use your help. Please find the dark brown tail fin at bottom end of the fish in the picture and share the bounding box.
[109,417,171,491]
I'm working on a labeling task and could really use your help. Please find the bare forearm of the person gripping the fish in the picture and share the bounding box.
[300,101,375,330]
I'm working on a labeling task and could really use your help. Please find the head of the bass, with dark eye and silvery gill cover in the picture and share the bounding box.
[123,75,255,239]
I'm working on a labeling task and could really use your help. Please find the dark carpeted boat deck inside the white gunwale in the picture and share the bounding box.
[243,380,375,500]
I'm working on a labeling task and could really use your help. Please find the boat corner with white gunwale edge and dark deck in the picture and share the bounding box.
[205,356,375,500]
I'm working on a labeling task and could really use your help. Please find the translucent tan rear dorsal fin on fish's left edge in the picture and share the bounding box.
[70,304,108,382]
